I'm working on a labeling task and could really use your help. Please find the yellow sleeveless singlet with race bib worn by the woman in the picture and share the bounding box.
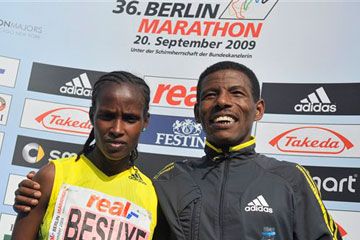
[39,155,157,239]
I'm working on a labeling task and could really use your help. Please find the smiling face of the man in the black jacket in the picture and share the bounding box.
[194,69,264,148]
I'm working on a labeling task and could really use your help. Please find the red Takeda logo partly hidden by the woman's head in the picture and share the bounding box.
[35,107,92,135]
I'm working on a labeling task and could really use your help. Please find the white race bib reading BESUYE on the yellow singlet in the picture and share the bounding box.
[49,184,151,240]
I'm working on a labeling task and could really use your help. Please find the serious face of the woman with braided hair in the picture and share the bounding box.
[90,83,148,161]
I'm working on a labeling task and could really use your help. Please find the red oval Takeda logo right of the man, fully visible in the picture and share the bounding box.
[269,126,354,154]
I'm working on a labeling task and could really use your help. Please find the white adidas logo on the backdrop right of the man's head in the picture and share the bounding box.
[294,87,336,112]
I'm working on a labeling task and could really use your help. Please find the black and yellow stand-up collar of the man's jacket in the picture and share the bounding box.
[205,136,255,161]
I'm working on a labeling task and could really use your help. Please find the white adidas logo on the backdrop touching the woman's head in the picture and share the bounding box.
[60,73,92,97]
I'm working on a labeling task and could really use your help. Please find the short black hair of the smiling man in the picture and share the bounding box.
[196,61,260,102]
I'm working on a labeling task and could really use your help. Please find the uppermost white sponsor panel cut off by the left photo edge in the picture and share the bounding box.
[0,56,20,87]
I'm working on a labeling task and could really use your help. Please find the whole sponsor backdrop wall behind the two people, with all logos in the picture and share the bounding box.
[0,0,360,236]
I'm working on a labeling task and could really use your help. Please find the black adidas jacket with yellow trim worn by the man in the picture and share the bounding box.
[154,140,341,240]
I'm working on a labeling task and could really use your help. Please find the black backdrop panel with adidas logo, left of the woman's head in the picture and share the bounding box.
[28,62,104,99]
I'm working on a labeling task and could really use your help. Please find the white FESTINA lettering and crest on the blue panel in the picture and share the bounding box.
[155,119,205,148]
